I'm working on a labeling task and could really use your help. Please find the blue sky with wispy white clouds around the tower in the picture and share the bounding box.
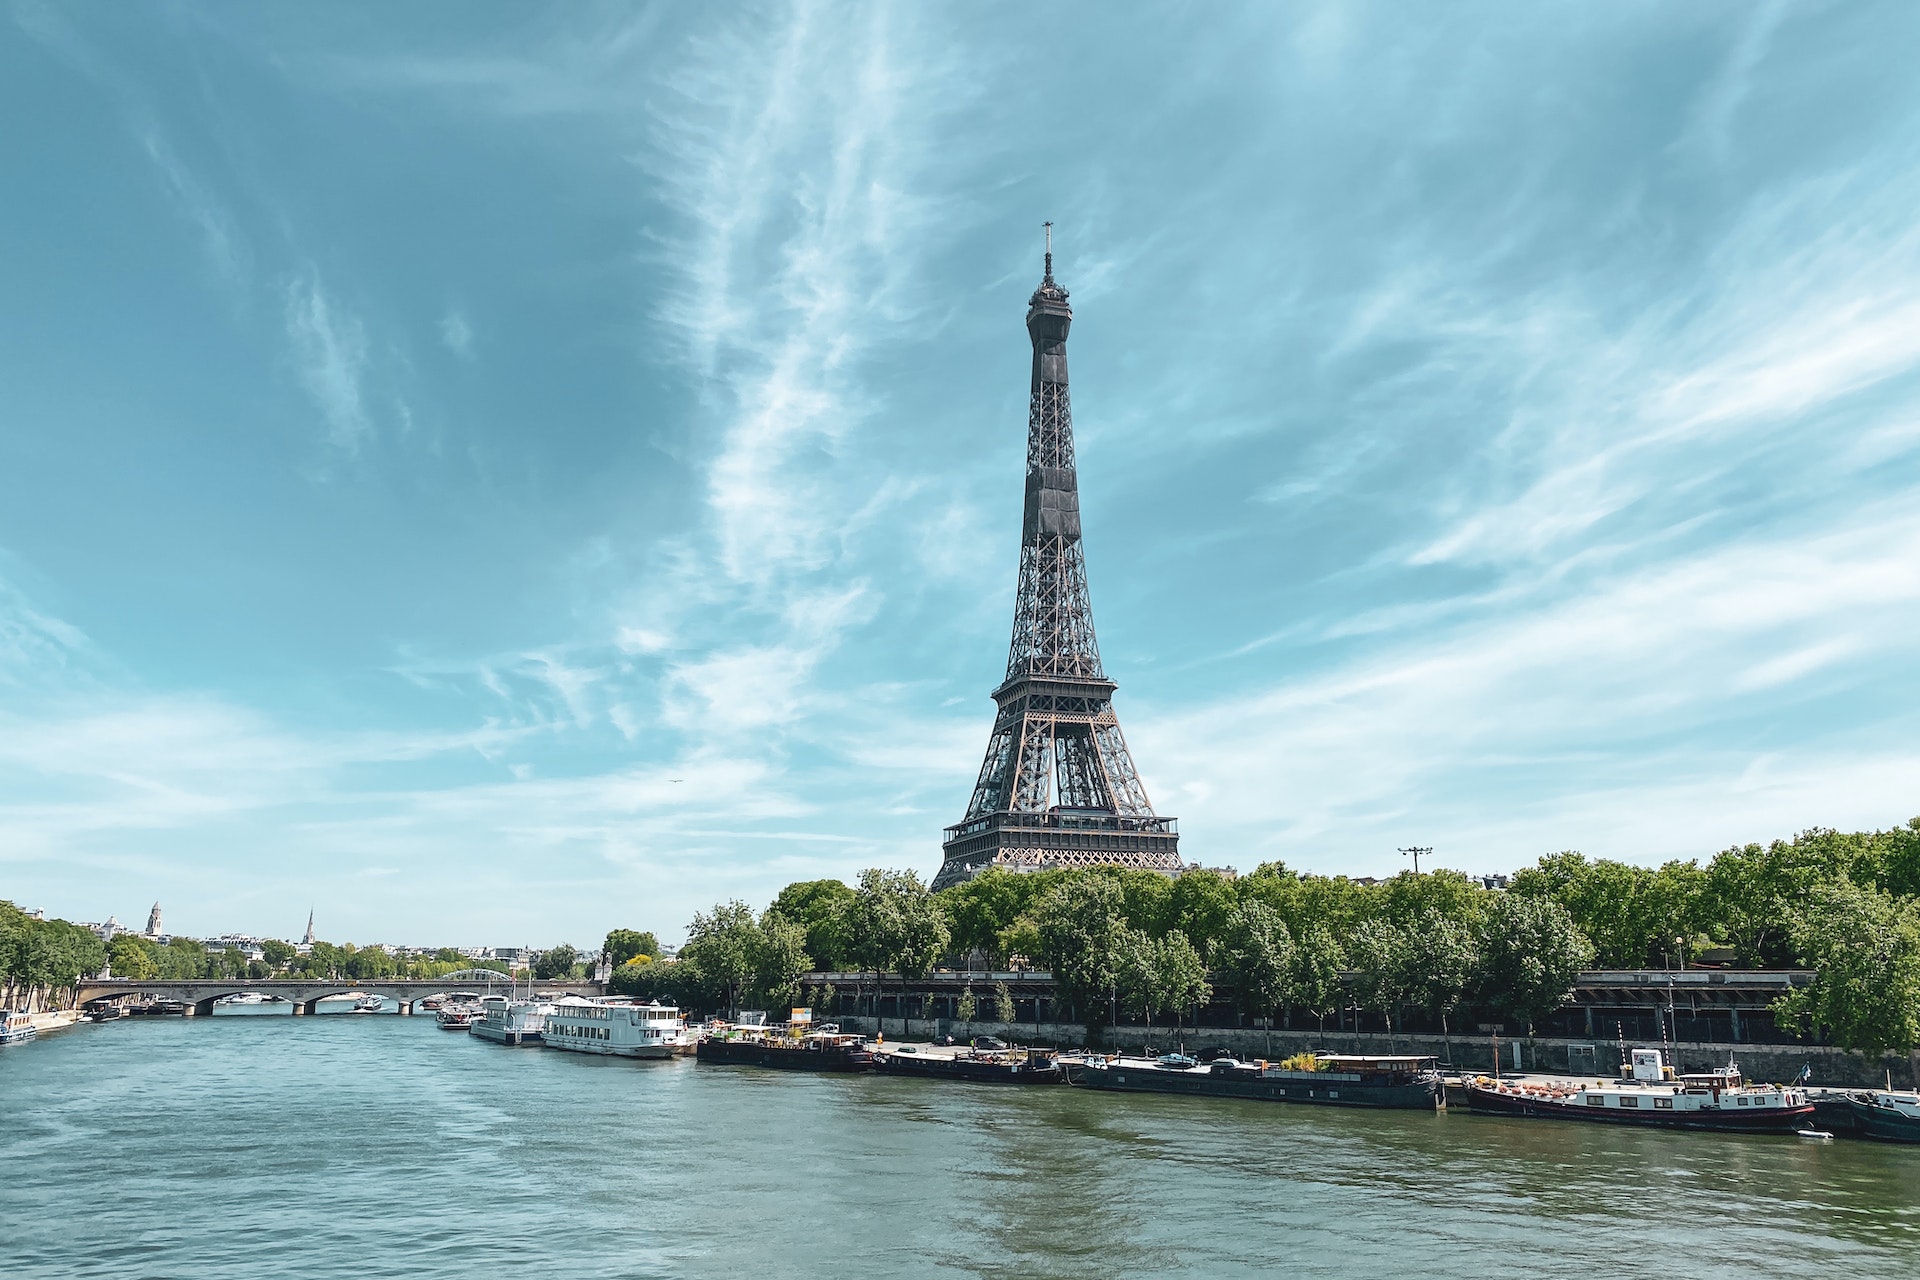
[0,2,1920,944]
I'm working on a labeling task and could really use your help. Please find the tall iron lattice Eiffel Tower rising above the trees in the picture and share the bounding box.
[933,223,1181,889]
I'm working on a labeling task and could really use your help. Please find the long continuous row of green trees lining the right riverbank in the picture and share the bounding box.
[609,818,1920,1052]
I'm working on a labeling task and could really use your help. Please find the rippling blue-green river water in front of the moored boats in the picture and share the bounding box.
[0,1017,1920,1280]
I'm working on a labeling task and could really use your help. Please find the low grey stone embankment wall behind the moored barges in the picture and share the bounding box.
[835,1017,1920,1088]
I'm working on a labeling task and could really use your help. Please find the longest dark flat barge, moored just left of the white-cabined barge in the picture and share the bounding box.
[1064,1054,1446,1111]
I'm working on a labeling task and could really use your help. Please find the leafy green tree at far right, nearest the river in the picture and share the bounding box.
[1774,879,1920,1057]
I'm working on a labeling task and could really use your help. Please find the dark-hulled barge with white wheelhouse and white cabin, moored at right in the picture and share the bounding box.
[1467,1050,1814,1134]
